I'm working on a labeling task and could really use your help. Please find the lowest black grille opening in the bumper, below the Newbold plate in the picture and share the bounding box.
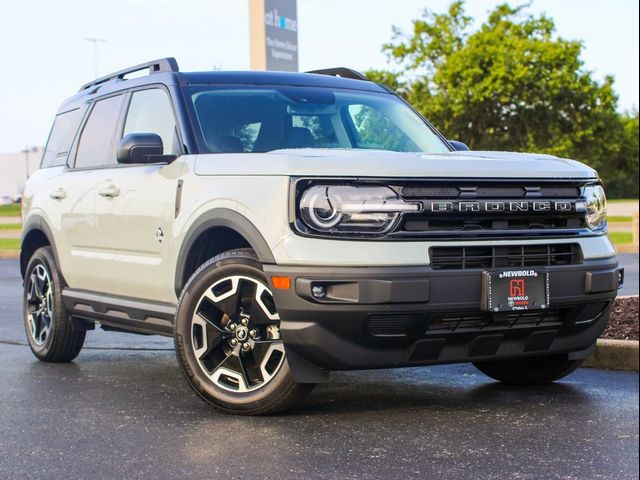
[425,309,562,335]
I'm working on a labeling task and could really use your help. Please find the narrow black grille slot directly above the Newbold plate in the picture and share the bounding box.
[430,243,582,270]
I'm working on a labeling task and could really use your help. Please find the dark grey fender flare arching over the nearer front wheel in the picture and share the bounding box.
[174,208,276,298]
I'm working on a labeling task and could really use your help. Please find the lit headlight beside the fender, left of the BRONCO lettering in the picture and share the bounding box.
[299,185,421,235]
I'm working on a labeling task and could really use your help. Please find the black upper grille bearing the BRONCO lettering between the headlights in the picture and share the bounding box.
[393,180,587,238]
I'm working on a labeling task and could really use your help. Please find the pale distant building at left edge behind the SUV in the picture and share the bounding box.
[0,147,42,199]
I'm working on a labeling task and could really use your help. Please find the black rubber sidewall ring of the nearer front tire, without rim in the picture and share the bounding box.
[175,255,293,411]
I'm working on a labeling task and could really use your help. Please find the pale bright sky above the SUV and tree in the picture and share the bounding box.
[0,0,639,152]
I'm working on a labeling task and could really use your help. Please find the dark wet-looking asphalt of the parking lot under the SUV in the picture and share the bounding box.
[0,260,639,480]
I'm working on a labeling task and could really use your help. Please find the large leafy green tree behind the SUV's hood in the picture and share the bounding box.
[376,1,638,197]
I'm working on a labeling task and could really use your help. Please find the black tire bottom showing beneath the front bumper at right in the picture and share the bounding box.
[473,355,583,385]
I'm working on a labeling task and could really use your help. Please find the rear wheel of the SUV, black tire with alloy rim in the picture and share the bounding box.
[23,247,86,362]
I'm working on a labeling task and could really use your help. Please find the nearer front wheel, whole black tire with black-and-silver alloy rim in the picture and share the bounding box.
[174,249,315,415]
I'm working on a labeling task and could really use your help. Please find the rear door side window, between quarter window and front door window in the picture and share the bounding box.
[75,95,124,168]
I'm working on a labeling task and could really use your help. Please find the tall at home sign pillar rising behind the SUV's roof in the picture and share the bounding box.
[249,0,298,72]
